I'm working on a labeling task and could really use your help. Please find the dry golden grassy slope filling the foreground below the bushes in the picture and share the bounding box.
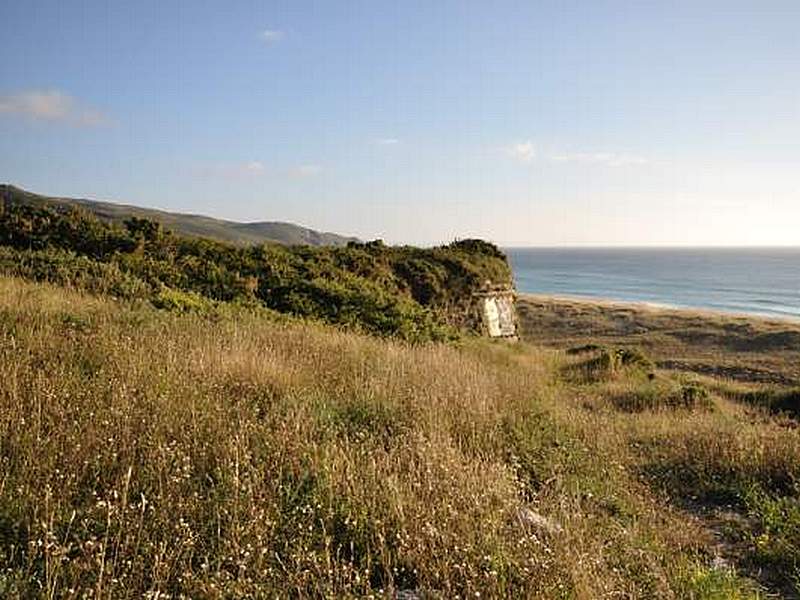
[0,279,800,598]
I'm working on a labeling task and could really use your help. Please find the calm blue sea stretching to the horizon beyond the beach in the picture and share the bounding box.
[504,247,800,320]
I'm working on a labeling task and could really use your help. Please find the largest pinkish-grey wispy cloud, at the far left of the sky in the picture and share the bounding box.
[0,90,110,127]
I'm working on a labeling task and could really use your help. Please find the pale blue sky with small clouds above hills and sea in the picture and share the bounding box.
[0,0,800,245]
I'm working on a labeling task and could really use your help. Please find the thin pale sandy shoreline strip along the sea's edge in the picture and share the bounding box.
[517,292,800,325]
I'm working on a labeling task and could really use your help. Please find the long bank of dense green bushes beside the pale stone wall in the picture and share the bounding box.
[0,204,511,340]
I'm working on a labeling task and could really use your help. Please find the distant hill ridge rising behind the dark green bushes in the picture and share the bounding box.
[0,184,358,246]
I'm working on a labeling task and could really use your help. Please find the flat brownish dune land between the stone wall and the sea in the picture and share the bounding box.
[517,294,800,385]
